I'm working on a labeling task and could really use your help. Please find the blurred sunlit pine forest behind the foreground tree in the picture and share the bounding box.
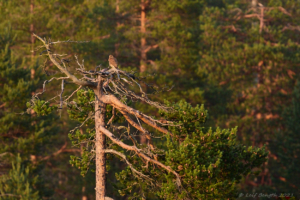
[0,0,300,199]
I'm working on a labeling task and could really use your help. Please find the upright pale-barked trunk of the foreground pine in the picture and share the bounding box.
[94,76,106,200]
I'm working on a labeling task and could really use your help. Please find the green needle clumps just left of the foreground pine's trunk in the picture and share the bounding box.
[67,89,123,176]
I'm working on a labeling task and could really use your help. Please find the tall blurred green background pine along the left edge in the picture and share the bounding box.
[0,28,59,196]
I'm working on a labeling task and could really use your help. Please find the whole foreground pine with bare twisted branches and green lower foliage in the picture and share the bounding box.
[30,35,267,200]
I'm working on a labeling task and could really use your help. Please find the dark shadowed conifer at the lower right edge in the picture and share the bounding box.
[268,80,300,198]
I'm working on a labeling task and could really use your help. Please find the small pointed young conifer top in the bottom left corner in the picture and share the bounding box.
[0,155,40,200]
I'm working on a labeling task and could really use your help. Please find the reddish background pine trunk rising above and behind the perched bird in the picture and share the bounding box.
[140,0,147,72]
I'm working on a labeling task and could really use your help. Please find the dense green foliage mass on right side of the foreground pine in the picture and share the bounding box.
[116,101,267,199]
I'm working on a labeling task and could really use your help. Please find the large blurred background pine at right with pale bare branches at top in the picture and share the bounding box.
[193,1,299,192]
